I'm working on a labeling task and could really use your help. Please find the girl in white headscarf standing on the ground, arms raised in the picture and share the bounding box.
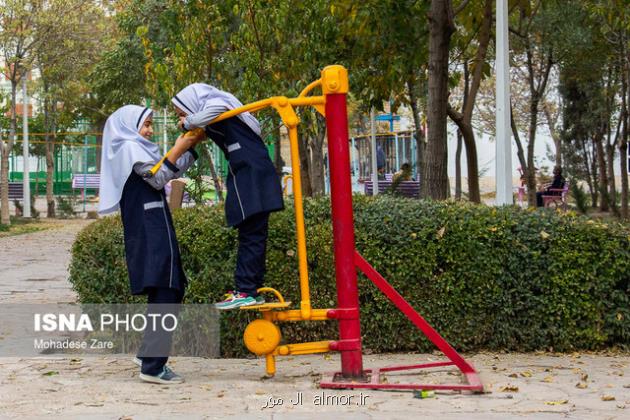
[99,105,202,384]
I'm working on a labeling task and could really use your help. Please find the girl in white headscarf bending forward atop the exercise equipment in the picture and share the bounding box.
[172,83,284,309]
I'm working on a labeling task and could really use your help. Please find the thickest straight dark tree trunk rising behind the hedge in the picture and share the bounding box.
[422,0,455,200]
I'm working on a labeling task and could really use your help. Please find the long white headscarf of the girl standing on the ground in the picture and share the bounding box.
[98,105,161,214]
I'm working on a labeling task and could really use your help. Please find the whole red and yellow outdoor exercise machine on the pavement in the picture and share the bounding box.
[155,65,483,392]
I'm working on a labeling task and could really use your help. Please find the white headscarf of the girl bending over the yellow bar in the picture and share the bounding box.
[171,83,260,136]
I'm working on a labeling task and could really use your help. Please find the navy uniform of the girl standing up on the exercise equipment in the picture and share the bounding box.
[205,117,284,296]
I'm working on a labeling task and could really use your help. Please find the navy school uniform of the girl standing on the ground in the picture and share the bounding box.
[119,155,197,375]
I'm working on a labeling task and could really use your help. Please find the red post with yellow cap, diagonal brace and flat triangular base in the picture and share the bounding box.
[320,66,483,392]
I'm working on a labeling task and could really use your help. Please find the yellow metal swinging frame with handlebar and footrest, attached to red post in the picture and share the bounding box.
[151,65,348,376]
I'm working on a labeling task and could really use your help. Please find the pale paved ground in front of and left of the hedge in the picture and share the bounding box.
[0,220,630,420]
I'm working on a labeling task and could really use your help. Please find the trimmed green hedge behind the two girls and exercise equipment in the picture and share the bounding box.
[70,196,630,357]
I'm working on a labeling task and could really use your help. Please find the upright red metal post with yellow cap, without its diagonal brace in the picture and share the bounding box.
[322,66,364,379]
